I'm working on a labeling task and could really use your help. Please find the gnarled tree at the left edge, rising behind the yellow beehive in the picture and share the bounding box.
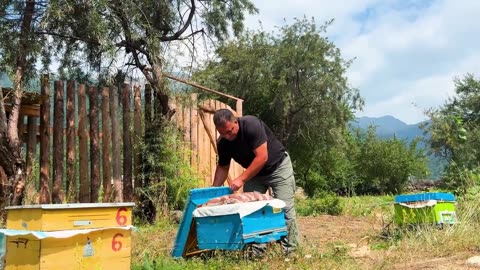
[0,0,45,204]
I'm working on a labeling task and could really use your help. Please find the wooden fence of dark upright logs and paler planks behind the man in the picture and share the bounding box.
[6,75,243,203]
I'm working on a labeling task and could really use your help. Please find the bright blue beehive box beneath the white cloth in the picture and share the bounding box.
[195,202,287,250]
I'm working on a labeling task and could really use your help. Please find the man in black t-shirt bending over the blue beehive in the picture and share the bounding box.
[213,109,298,254]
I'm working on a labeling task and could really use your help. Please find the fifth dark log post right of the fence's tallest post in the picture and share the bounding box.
[102,87,112,202]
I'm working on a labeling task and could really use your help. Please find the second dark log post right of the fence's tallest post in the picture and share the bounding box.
[66,80,77,202]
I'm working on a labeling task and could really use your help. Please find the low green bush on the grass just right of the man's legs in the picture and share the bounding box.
[295,192,343,216]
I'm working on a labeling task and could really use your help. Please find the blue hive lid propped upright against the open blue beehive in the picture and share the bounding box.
[172,187,232,257]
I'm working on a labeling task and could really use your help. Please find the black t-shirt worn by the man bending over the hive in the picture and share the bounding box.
[217,115,285,175]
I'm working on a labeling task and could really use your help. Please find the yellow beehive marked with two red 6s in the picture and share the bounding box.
[3,203,134,270]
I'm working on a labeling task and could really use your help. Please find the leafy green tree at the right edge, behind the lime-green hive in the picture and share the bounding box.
[424,74,480,192]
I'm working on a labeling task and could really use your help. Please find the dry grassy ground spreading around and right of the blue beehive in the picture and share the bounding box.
[132,193,480,270]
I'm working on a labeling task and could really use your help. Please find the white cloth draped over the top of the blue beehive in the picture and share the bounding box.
[193,199,285,218]
